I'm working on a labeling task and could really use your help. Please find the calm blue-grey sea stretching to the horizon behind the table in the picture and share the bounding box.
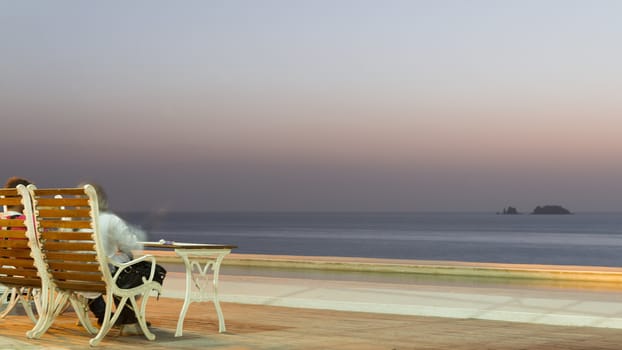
[121,213,622,266]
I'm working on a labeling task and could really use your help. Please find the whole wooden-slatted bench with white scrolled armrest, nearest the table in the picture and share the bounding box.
[26,185,161,346]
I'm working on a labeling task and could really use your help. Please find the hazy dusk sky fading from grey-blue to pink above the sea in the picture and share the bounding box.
[0,0,622,212]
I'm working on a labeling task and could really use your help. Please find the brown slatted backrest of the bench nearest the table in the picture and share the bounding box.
[28,185,110,293]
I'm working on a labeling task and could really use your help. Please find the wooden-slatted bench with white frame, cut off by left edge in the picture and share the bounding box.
[0,186,41,323]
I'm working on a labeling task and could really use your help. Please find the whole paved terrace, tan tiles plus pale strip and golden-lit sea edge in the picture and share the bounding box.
[0,256,622,350]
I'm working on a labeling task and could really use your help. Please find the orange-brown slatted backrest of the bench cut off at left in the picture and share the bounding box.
[0,186,41,287]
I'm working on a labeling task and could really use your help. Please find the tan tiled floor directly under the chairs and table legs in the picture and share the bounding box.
[0,298,622,350]
